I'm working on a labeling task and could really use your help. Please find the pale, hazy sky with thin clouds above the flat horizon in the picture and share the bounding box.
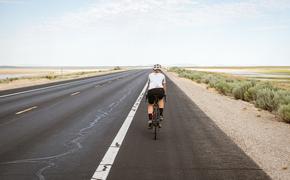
[0,0,290,66]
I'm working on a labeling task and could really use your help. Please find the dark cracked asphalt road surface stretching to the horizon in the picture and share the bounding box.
[0,70,269,180]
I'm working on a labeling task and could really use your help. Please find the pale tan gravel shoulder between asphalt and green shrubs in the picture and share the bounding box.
[166,72,290,180]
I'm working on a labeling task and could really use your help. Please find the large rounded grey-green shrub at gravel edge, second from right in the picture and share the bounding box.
[255,88,278,111]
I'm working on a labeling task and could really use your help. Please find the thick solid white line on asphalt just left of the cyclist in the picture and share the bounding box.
[91,83,148,180]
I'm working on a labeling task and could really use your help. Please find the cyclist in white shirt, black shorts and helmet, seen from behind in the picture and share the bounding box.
[147,64,166,128]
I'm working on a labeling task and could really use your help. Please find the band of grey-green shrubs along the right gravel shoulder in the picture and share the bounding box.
[169,67,290,123]
